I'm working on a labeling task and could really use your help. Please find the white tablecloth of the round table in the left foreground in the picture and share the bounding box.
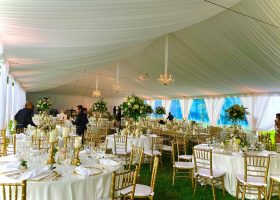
[0,152,124,200]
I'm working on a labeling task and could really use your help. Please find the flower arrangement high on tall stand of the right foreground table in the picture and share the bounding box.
[226,104,249,123]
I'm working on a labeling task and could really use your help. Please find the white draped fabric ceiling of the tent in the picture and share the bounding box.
[0,0,280,98]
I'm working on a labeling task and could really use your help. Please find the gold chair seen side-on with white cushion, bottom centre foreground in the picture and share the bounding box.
[122,157,159,200]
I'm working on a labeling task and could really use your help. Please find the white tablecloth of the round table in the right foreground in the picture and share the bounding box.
[198,145,280,199]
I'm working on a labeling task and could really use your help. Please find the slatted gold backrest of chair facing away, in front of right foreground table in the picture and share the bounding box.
[244,154,270,183]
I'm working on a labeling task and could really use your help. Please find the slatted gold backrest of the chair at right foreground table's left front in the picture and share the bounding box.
[193,148,213,176]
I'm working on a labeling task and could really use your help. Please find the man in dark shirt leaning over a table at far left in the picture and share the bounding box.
[15,102,36,129]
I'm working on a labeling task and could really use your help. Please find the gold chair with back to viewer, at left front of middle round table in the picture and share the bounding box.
[113,135,130,165]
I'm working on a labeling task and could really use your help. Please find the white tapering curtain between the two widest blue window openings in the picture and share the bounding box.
[204,97,225,126]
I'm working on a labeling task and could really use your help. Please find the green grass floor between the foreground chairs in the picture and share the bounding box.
[140,158,277,200]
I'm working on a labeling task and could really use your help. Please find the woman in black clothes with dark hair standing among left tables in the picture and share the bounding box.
[72,105,88,138]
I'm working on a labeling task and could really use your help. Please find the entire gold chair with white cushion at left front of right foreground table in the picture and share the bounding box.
[193,148,226,200]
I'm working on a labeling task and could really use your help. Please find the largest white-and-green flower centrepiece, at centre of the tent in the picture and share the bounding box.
[121,94,150,121]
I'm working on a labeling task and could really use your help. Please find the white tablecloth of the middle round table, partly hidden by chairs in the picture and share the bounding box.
[106,135,156,151]
